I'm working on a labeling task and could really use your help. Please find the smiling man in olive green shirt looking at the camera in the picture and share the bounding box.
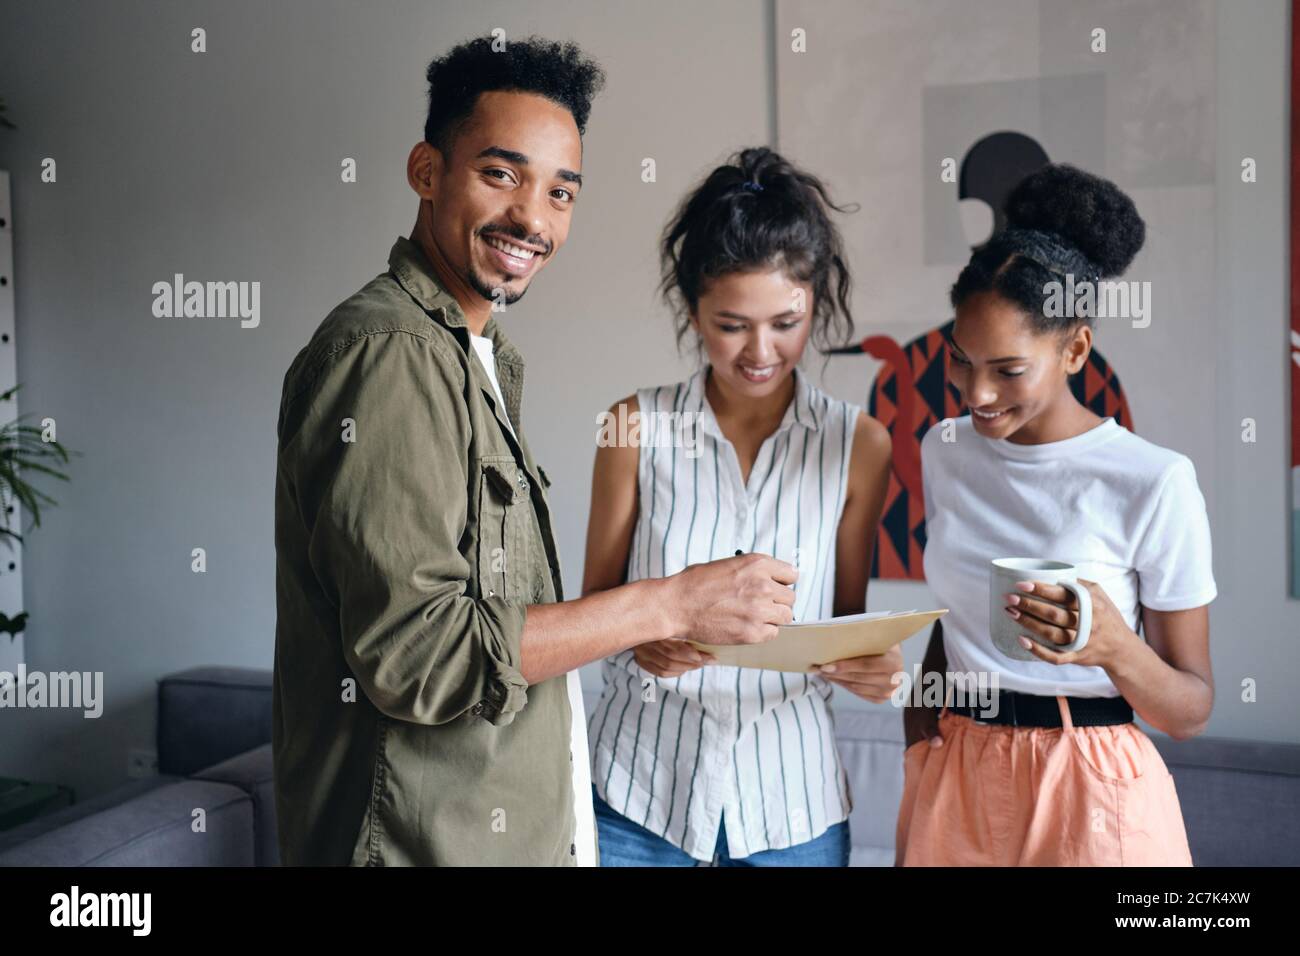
[273,39,796,865]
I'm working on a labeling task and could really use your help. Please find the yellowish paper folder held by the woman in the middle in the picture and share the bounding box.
[688,609,948,674]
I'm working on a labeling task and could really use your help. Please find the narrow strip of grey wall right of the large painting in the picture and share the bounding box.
[1206,0,1300,741]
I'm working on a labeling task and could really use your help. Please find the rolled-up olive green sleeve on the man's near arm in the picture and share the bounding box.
[281,332,528,724]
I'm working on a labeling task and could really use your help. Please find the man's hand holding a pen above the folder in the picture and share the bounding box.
[666,554,798,644]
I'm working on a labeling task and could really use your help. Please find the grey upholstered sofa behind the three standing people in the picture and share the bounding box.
[0,667,1300,866]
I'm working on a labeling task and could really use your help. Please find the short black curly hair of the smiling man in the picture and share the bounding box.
[424,36,605,156]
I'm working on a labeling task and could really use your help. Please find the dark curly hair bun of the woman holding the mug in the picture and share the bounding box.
[1006,163,1147,277]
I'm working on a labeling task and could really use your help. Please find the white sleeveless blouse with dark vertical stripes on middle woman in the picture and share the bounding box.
[589,365,862,861]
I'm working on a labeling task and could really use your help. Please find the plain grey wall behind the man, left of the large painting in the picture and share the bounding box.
[0,0,771,797]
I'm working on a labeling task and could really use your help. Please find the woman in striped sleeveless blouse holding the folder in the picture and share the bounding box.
[582,148,902,866]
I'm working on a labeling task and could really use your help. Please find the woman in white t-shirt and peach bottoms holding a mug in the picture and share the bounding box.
[896,165,1217,866]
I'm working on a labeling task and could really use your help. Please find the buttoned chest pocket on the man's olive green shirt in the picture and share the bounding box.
[478,455,532,602]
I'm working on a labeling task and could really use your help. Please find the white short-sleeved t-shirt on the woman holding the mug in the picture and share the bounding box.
[920,415,1218,697]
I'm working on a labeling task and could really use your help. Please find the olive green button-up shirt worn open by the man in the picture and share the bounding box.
[272,238,574,865]
